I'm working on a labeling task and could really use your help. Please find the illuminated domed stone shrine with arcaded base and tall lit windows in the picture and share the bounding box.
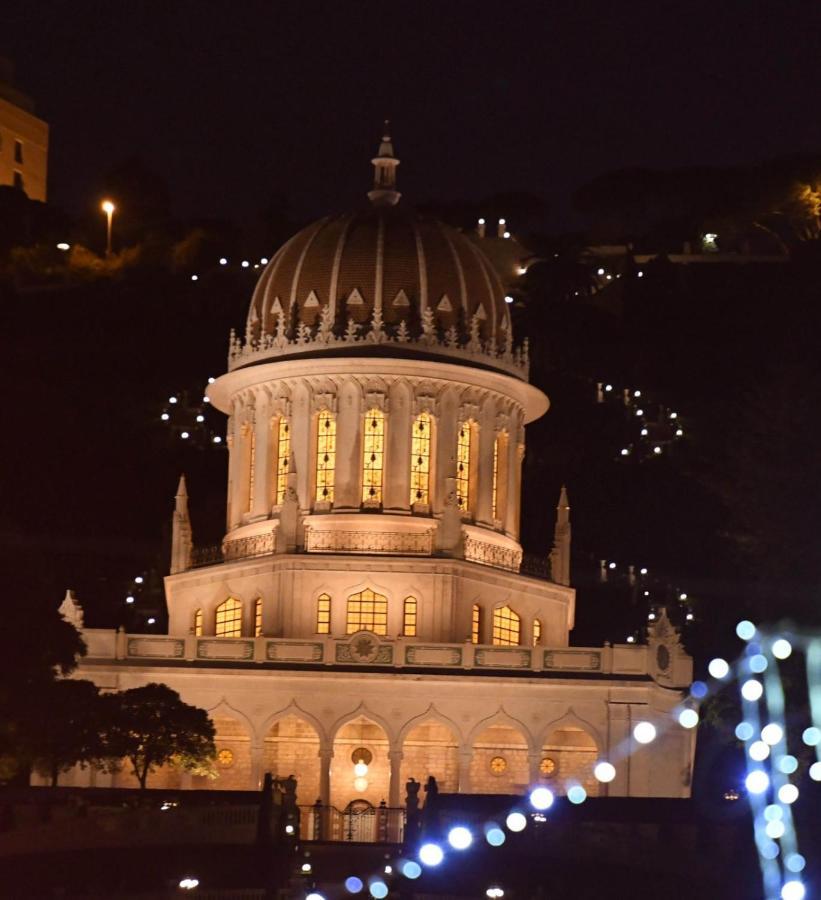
[66,136,694,836]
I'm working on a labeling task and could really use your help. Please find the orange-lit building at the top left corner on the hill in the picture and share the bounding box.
[0,57,48,202]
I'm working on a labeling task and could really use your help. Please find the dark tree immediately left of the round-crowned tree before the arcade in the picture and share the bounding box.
[29,678,104,787]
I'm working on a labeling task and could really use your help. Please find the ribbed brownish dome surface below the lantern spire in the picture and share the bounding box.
[248,206,510,342]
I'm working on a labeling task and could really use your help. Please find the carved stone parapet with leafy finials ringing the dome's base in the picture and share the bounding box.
[228,306,530,381]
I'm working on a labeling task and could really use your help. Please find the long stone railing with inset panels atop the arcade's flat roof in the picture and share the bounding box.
[83,629,692,685]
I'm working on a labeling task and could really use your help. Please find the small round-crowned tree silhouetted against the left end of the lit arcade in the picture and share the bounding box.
[106,682,217,790]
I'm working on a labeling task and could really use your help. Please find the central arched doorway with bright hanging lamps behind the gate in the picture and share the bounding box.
[331,716,390,811]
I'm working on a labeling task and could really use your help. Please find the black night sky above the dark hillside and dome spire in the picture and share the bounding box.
[6,0,821,228]
